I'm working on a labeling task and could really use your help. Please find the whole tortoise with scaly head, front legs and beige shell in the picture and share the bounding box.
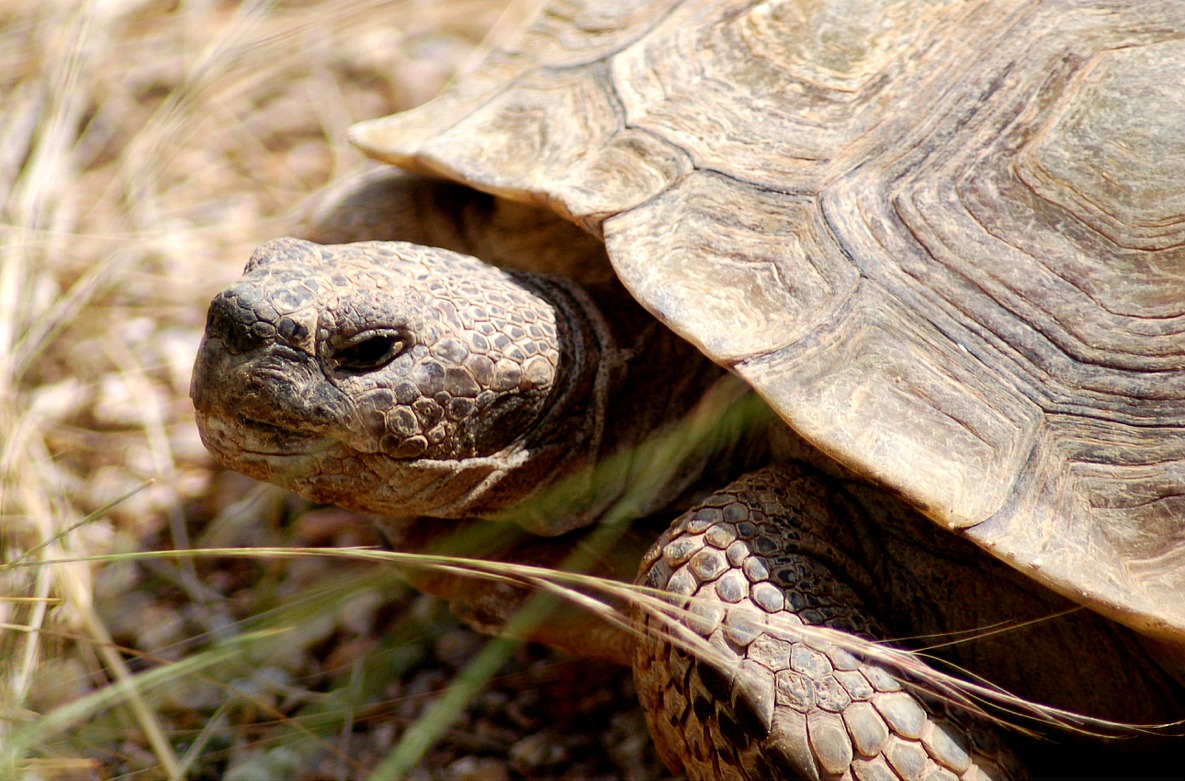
[192,0,1185,779]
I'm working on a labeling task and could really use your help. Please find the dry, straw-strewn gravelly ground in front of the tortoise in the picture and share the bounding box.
[0,0,664,781]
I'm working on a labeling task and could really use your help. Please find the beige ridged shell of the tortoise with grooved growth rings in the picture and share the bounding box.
[352,0,1185,664]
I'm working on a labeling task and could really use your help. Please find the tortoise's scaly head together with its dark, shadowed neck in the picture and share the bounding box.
[191,239,722,534]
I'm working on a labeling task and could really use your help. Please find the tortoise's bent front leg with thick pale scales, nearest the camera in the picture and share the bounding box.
[634,467,1016,780]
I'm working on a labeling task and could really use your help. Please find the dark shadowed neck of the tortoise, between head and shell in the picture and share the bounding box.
[483,275,764,534]
